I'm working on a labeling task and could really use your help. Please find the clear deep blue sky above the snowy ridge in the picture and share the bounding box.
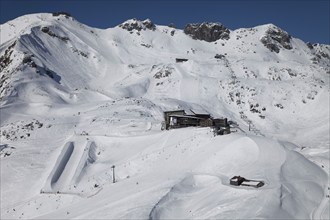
[0,0,330,44]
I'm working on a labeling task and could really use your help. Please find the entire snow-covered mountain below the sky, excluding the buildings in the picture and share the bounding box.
[0,13,330,219]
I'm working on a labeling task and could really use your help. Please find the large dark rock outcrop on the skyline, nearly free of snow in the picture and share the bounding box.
[184,22,230,42]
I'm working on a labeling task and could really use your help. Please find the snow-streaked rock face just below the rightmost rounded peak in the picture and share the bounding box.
[260,26,292,53]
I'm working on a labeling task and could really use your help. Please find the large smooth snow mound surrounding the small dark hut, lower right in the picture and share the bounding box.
[150,138,327,219]
